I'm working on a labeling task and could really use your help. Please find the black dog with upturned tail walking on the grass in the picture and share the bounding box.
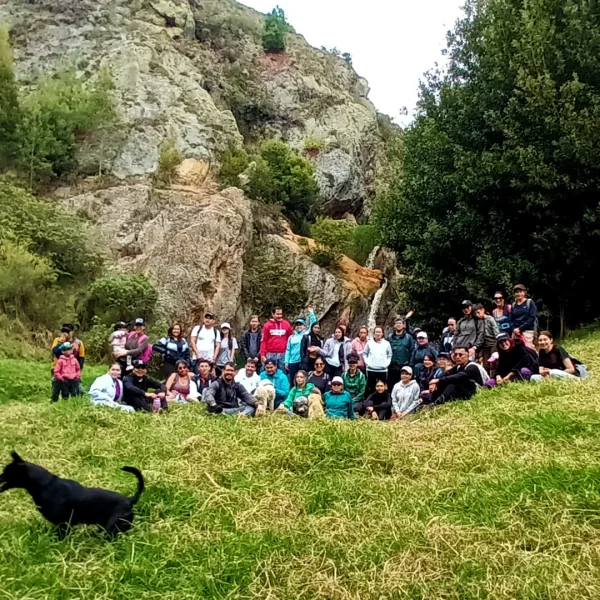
[0,452,144,536]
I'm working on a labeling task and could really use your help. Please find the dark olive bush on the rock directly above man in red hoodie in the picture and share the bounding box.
[243,247,308,318]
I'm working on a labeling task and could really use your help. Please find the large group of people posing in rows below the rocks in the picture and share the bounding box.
[52,284,587,420]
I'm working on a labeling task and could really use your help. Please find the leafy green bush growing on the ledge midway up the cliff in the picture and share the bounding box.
[246,140,319,232]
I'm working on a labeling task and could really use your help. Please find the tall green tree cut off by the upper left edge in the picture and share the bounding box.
[0,27,21,168]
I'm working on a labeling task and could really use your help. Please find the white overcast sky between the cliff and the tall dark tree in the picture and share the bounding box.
[239,0,463,123]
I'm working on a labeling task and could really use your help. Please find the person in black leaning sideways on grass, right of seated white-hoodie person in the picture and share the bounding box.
[429,346,487,405]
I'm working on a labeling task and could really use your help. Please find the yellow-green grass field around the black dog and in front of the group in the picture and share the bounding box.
[0,334,600,600]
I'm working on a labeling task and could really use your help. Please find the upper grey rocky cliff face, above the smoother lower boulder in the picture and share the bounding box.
[0,0,392,216]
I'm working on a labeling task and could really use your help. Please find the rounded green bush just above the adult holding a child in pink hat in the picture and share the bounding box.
[79,274,158,327]
